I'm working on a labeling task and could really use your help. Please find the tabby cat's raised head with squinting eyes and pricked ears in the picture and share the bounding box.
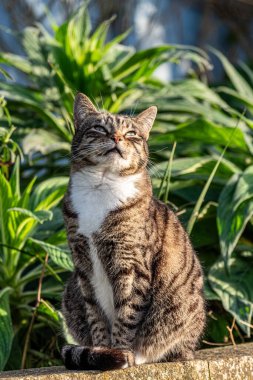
[72,93,157,175]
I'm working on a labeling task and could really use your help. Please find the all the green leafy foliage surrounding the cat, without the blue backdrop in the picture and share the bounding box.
[0,5,253,368]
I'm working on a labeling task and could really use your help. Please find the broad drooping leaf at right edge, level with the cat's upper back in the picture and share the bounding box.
[217,166,253,262]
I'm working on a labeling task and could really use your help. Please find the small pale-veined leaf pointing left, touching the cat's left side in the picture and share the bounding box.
[29,238,74,271]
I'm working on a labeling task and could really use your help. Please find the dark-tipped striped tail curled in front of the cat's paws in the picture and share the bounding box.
[61,345,134,371]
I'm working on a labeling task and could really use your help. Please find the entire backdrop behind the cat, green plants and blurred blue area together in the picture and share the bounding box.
[0,0,253,370]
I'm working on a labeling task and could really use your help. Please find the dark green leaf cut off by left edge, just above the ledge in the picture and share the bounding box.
[0,288,13,370]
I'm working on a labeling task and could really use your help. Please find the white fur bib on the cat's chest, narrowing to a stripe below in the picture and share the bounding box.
[71,171,140,323]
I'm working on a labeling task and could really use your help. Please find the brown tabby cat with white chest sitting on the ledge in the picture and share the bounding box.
[62,93,205,370]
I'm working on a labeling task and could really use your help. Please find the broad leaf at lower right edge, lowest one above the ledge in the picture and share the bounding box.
[208,257,253,336]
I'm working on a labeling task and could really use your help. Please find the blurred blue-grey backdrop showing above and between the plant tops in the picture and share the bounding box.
[0,0,253,81]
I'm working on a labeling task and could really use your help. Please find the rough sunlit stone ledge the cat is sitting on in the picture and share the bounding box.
[0,343,253,380]
